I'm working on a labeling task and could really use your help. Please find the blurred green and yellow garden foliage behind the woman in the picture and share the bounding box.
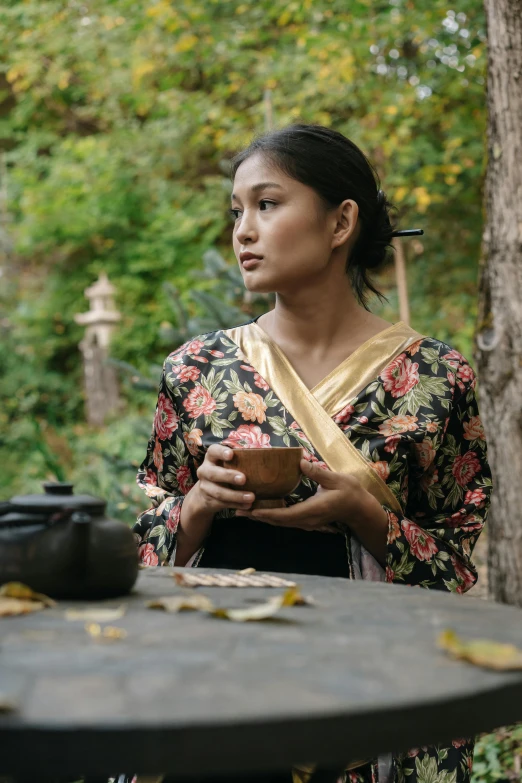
[0,0,512,783]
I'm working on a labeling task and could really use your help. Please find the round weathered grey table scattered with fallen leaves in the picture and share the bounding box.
[0,568,522,777]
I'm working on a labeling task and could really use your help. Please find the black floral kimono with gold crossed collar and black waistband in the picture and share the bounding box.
[135,321,491,783]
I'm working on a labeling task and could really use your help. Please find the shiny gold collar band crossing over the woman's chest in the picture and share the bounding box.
[224,321,422,513]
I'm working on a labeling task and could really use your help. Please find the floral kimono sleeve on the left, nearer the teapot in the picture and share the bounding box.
[133,357,197,565]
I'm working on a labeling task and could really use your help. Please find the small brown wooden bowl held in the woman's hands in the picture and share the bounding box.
[226,446,303,508]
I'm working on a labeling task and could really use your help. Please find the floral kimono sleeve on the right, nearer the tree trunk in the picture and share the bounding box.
[385,374,492,593]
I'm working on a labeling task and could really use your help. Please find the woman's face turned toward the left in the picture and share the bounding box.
[231,154,350,293]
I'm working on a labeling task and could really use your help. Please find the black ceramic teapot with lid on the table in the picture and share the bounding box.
[0,483,138,599]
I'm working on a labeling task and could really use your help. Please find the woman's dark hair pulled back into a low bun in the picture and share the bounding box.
[231,124,394,309]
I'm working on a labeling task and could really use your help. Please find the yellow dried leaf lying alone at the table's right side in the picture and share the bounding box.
[438,628,522,671]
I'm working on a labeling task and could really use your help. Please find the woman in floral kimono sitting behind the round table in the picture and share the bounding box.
[135,125,491,783]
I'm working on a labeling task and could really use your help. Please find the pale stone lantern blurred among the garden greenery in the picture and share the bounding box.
[74,272,121,427]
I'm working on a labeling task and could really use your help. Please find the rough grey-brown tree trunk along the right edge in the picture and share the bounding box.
[477,0,522,606]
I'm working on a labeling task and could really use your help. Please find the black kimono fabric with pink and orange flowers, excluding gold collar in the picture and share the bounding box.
[134,331,492,783]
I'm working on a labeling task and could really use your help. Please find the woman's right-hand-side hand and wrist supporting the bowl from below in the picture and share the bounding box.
[236,459,388,562]
